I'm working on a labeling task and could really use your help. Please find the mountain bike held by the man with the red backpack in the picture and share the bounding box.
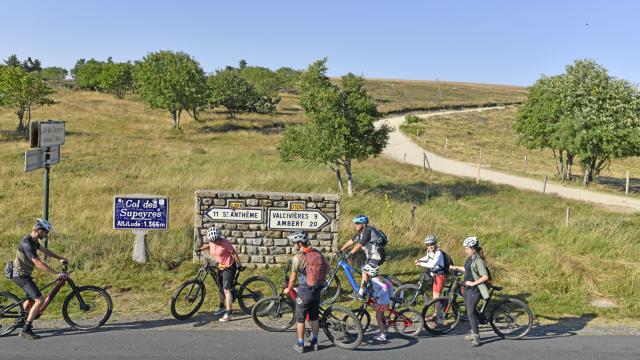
[251,262,364,350]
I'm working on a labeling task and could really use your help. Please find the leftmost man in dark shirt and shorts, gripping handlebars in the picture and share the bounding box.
[11,219,67,340]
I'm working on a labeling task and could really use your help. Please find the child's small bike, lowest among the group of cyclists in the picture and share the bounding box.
[353,284,424,337]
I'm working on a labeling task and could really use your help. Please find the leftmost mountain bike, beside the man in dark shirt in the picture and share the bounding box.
[0,261,113,336]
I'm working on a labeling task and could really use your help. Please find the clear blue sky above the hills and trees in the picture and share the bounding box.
[0,0,640,85]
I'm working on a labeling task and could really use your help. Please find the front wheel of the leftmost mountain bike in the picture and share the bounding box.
[62,285,113,330]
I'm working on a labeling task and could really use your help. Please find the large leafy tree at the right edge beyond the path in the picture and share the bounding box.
[515,60,640,181]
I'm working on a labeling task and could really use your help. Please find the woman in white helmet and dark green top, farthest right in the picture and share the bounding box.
[451,236,489,346]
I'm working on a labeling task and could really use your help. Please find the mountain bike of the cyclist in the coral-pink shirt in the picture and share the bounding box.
[171,258,276,320]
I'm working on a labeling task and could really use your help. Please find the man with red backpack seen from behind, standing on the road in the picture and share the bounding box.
[282,231,329,353]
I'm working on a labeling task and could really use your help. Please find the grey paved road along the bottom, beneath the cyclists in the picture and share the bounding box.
[0,320,640,360]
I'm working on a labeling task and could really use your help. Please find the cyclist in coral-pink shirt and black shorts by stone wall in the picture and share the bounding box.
[200,226,242,321]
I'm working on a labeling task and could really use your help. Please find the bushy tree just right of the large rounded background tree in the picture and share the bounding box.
[208,69,259,119]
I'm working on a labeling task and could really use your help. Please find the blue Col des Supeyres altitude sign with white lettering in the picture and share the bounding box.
[113,196,169,230]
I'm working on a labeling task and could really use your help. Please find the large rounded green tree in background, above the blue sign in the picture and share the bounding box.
[133,51,206,128]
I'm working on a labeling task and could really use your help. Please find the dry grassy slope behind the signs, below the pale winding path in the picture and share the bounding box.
[0,86,640,319]
